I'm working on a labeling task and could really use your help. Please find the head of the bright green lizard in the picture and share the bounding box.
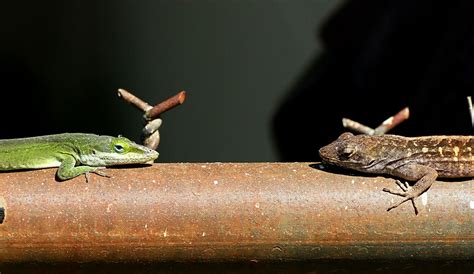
[80,136,158,166]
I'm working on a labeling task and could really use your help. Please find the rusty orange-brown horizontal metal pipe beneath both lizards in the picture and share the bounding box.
[0,163,474,262]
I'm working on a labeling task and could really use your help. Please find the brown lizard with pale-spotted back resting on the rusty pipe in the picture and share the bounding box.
[319,133,474,214]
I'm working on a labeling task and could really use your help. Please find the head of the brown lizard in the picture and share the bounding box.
[319,132,375,171]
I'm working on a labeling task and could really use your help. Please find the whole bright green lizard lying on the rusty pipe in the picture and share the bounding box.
[0,133,158,181]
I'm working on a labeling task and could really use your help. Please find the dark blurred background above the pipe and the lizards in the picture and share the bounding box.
[0,0,474,162]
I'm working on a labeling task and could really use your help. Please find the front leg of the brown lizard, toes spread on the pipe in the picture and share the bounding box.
[383,164,438,214]
